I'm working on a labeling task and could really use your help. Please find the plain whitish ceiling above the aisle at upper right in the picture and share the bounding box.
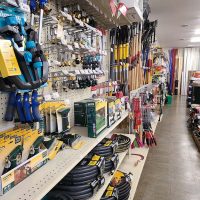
[149,0,200,48]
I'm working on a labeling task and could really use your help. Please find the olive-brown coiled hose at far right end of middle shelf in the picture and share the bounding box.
[112,134,131,153]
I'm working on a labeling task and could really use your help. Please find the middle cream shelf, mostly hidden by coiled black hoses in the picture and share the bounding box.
[90,134,135,200]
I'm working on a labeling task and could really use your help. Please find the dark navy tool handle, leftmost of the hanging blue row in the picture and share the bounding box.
[5,92,16,121]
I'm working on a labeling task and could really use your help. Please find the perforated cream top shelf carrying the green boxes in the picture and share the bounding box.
[0,112,128,200]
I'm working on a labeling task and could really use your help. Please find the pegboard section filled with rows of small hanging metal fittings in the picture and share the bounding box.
[39,1,109,125]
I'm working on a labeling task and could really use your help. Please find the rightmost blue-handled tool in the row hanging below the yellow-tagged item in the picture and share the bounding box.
[31,90,42,122]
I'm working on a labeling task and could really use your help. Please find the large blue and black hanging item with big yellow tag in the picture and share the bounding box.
[0,5,48,91]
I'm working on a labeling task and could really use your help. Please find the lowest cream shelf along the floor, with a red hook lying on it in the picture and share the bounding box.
[119,116,159,200]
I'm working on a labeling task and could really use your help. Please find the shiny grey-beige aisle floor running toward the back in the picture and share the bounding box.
[134,97,200,200]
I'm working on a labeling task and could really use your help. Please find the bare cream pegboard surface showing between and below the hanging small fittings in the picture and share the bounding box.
[36,0,109,124]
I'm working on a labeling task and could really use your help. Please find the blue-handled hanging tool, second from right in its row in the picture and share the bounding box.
[23,92,33,123]
